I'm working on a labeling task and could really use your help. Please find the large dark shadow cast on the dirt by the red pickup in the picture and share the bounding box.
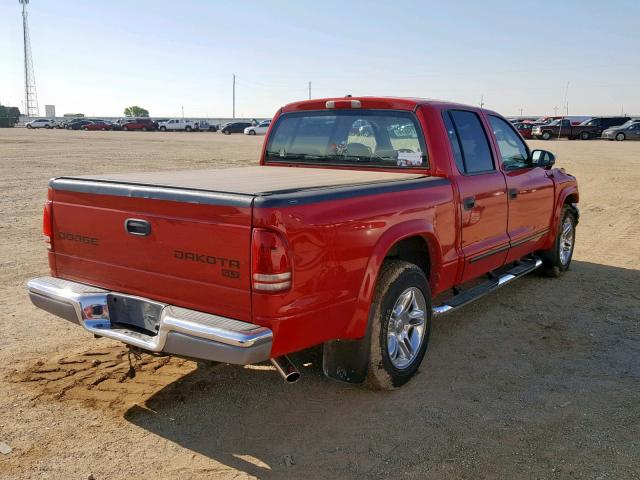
[125,261,640,478]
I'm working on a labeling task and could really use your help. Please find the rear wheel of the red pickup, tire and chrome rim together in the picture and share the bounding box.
[366,260,431,390]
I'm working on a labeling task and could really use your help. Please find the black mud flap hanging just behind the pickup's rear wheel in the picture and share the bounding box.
[322,335,370,383]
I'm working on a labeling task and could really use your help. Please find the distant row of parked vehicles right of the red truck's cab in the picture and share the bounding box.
[512,116,640,141]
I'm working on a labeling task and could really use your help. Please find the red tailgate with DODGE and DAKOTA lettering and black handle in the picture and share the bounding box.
[51,179,253,320]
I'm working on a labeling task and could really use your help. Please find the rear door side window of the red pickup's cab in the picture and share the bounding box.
[443,110,495,174]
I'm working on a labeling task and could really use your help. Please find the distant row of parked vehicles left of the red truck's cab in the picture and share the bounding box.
[25,117,271,135]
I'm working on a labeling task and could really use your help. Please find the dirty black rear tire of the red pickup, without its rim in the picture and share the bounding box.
[365,260,431,390]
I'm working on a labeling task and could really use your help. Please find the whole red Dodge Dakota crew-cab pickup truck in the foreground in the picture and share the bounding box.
[28,97,579,388]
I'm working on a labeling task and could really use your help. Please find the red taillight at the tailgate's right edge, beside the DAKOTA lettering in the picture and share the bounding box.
[251,228,291,293]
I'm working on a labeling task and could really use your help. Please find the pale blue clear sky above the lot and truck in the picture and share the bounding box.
[0,0,640,118]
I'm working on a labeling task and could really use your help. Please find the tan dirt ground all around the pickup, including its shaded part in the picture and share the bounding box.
[0,129,640,480]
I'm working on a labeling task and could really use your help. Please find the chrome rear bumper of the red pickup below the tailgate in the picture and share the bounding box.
[27,277,273,365]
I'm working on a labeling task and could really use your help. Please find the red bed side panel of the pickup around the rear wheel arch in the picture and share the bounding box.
[252,179,457,356]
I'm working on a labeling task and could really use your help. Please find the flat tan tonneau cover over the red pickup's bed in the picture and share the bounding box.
[59,166,425,195]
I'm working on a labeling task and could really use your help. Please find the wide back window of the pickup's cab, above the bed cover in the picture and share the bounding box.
[265,110,428,168]
